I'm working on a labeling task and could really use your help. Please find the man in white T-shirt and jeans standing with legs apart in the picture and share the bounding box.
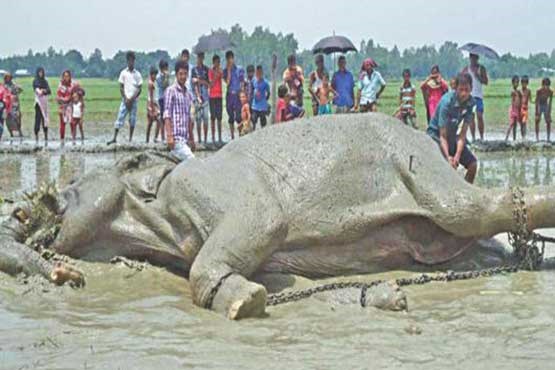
[108,51,143,145]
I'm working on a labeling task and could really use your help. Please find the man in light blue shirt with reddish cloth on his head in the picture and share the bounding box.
[355,58,385,113]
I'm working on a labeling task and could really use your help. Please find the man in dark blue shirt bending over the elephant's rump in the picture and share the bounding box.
[427,73,478,184]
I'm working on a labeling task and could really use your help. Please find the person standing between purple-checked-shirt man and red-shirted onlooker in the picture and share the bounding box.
[191,53,210,144]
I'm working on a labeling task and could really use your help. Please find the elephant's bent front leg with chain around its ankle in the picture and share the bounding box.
[190,199,287,319]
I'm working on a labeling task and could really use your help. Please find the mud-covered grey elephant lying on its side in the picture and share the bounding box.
[0,114,555,319]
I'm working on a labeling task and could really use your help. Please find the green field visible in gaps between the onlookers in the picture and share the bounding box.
[8,78,540,132]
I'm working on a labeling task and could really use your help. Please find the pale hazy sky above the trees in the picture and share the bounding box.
[4,0,555,57]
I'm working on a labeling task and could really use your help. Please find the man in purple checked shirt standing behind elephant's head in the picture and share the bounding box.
[163,60,195,161]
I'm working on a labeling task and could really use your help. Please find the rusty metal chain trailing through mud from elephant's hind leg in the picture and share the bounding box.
[267,188,555,307]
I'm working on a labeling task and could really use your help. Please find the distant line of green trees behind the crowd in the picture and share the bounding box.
[0,24,555,79]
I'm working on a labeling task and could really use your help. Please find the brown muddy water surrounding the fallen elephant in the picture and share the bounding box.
[0,153,555,369]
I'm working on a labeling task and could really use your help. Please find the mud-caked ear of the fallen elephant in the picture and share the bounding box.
[116,152,178,202]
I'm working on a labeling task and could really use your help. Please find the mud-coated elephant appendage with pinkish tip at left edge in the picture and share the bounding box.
[0,235,85,286]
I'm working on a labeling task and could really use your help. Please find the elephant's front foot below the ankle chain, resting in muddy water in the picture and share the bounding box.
[212,274,267,320]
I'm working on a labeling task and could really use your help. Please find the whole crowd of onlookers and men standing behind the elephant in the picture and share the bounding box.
[0,49,553,182]
